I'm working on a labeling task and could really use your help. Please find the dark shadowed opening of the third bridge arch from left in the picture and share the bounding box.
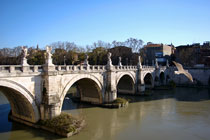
[117,74,135,94]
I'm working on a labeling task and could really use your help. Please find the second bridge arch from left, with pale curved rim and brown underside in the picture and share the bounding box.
[60,74,103,109]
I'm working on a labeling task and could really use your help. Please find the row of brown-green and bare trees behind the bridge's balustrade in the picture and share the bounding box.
[0,38,143,65]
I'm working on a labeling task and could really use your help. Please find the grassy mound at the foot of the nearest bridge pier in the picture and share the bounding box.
[39,113,82,133]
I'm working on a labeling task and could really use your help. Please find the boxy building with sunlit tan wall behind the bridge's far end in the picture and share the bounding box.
[143,42,175,65]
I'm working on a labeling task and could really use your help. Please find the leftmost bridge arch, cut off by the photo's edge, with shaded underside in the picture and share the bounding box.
[0,79,40,123]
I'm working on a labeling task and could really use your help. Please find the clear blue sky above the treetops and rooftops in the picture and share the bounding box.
[0,0,210,48]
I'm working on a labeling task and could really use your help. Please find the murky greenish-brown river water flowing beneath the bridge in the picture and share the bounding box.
[0,88,210,140]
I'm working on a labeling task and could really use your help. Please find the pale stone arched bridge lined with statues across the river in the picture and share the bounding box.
[0,48,170,123]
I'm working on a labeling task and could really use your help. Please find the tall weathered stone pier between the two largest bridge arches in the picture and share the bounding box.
[40,55,61,120]
